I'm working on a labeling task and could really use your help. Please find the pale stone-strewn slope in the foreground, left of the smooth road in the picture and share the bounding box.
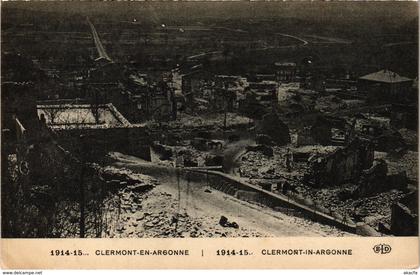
[103,189,270,238]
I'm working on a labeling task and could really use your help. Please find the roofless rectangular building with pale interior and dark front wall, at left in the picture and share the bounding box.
[37,103,150,160]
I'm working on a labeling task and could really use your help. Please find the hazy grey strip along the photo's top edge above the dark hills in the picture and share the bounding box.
[2,1,418,25]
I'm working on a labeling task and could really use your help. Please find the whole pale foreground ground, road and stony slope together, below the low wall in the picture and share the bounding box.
[104,156,350,237]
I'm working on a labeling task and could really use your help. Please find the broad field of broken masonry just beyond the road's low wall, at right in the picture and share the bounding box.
[240,142,417,233]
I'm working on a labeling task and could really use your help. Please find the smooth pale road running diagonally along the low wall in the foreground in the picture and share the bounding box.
[113,154,351,237]
